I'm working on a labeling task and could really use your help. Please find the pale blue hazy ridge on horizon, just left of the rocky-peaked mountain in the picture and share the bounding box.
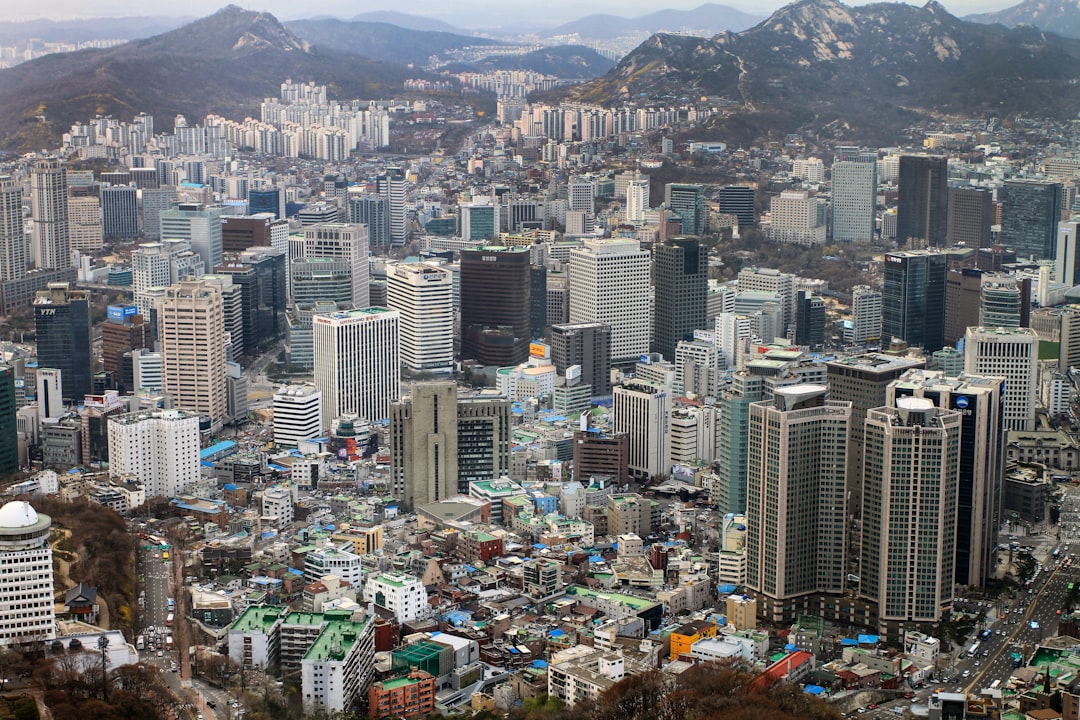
[542,3,764,40]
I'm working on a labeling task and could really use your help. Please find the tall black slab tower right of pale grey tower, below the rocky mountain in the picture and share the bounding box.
[896,155,948,248]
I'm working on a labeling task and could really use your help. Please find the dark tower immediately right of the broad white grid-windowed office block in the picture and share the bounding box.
[652,237,708,361]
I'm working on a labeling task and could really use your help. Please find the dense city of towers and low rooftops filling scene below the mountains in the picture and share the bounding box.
[0,1,1080,720]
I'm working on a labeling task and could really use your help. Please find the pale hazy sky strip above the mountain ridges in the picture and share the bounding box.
[0,0,1020,27]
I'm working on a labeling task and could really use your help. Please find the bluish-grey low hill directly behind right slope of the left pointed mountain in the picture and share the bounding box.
[286,19,496,66]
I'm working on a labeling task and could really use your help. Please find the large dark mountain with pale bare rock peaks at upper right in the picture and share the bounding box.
[568,0,1080,144]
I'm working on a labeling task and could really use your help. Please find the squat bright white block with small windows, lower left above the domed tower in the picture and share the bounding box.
[108,408,203,499]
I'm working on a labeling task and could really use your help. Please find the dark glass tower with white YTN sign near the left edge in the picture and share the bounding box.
[33,283,93,403]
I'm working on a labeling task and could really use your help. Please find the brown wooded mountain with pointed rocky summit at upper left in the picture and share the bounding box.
[0,5,417,151]
